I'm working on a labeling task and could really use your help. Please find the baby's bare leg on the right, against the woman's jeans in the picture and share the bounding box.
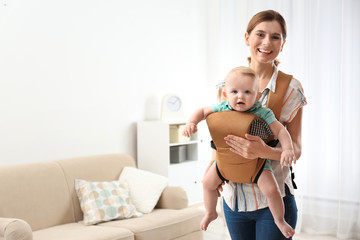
[258,169,295,238]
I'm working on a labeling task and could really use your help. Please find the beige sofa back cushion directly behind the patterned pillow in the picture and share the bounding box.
[56,154,135,222]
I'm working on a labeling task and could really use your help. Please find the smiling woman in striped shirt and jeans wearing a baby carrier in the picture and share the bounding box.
[217,10,306,240]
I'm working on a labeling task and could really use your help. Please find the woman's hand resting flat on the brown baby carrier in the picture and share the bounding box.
[224,134,268,159]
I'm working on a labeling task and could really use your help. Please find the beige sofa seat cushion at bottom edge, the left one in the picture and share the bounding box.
[33,223,134,240]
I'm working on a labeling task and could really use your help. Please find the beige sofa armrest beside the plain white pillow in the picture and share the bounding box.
[156,186,188,209]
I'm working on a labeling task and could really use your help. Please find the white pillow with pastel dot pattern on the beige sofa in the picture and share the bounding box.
[75,179,142,225]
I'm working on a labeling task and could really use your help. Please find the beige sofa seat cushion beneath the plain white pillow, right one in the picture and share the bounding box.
[99,207,204,240]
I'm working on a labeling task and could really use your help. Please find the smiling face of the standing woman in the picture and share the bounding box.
[245,20,285,63]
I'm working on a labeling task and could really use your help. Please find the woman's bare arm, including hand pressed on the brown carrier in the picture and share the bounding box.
[225,109,302,161]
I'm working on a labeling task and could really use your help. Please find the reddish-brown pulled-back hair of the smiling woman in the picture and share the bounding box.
[246,10,286,66]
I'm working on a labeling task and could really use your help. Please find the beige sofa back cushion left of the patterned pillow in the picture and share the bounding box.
[0,162,74,230]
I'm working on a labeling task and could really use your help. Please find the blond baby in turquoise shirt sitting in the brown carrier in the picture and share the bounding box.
[183,67,295,238]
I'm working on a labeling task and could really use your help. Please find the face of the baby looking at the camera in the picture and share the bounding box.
[225,73,258,112]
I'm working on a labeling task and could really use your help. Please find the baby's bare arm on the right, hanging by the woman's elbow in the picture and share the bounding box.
[269,121,296,166]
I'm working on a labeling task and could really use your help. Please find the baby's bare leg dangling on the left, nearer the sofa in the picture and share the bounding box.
[200,164,222,231]
